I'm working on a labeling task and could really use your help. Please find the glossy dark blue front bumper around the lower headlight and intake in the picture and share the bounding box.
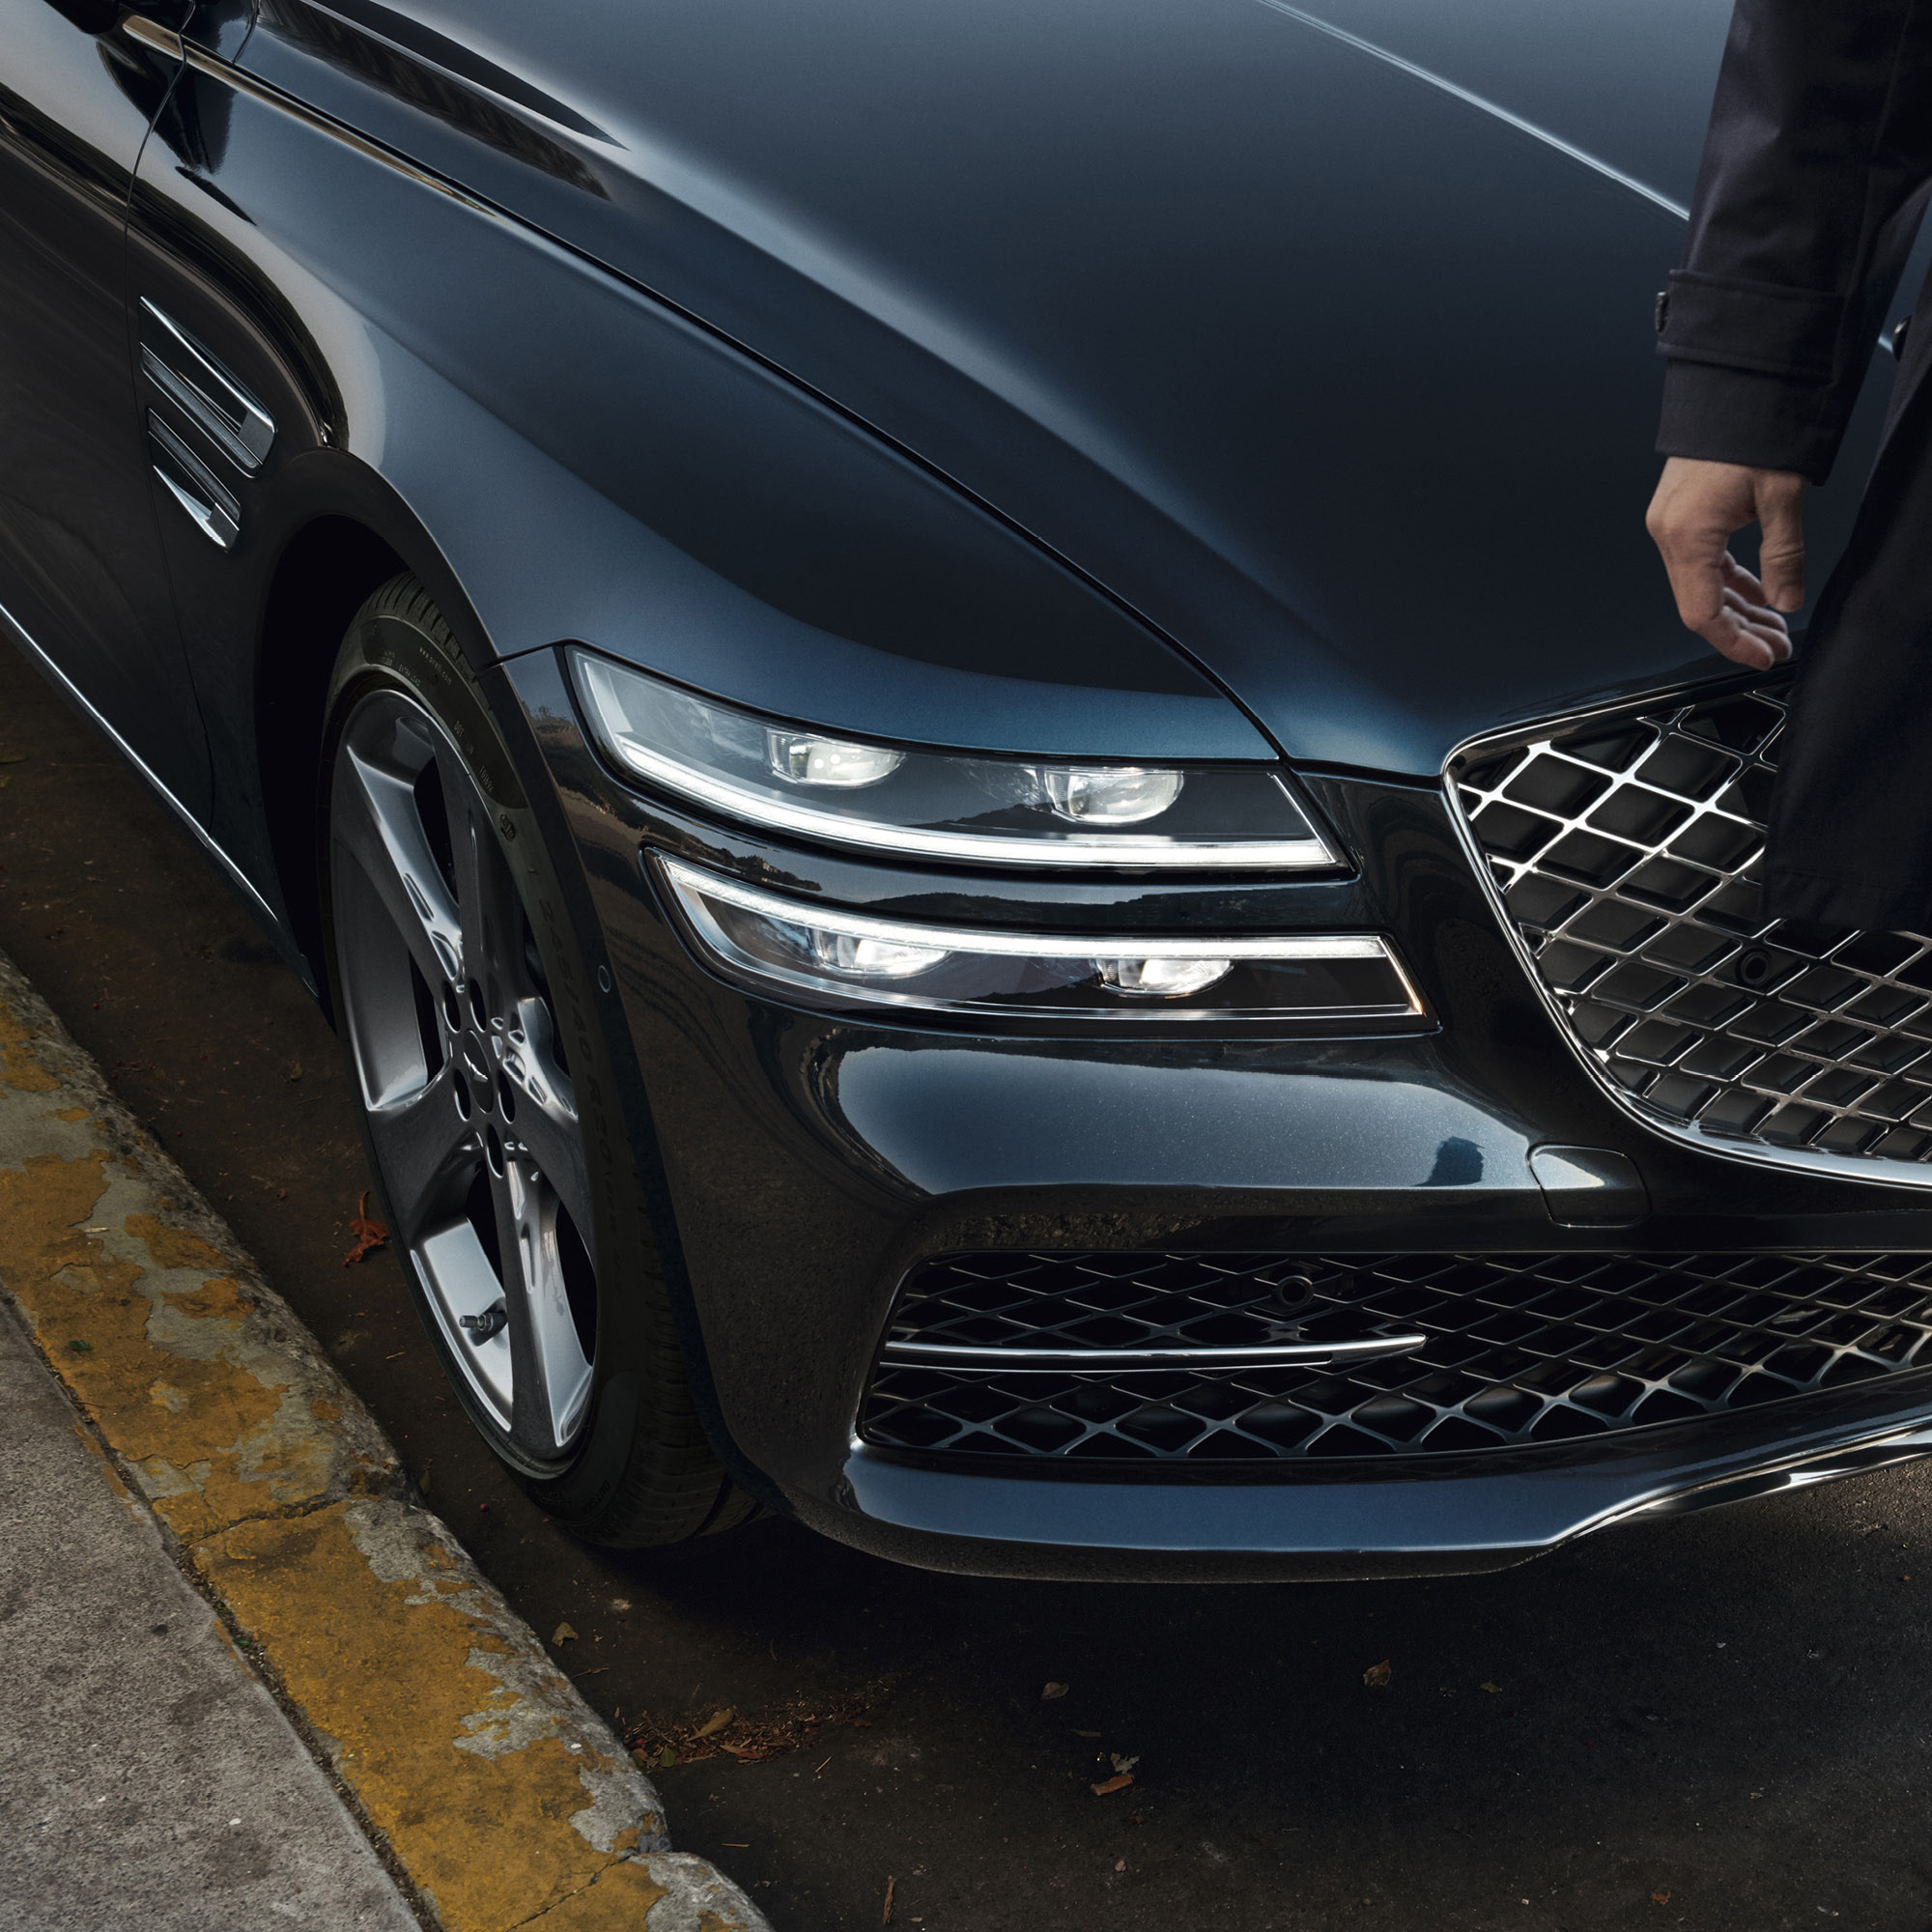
[502,653,1932,1578]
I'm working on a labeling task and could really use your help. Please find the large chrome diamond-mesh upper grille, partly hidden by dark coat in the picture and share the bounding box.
[1449,672,1932,1186]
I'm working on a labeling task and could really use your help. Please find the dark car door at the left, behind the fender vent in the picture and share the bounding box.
[0,0,209,821]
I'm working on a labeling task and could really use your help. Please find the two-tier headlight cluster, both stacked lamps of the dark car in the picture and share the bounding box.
[570,651,1424,1024]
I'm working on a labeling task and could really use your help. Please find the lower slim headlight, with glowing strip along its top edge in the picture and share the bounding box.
[657,858,1422,1022]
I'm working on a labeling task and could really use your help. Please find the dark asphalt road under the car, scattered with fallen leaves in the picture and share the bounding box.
[0,651,1932,1932]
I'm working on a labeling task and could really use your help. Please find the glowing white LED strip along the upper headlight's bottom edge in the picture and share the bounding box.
[607,726,1354,869]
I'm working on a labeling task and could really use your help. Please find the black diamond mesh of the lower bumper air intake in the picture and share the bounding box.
[860,1252,1932,1463]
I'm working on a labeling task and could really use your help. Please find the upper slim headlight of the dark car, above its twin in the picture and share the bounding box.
[570,651,1339,871]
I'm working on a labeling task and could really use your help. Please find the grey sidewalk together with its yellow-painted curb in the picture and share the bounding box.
[0,954,769,1932]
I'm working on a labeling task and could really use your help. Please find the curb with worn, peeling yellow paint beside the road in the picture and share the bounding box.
[0,952,771,1932]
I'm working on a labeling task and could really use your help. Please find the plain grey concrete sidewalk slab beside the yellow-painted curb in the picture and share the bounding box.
[0,1308,417,1932]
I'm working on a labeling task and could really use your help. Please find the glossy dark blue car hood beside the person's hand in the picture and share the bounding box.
[249,0,1847,775]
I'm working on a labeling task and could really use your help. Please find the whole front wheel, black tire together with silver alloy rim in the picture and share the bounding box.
[321,576,755,1548]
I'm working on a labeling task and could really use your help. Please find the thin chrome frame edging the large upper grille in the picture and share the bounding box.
[1441,667,1932,1192]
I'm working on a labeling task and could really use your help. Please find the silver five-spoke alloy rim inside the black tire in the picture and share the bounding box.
[330,692,597,1466]
